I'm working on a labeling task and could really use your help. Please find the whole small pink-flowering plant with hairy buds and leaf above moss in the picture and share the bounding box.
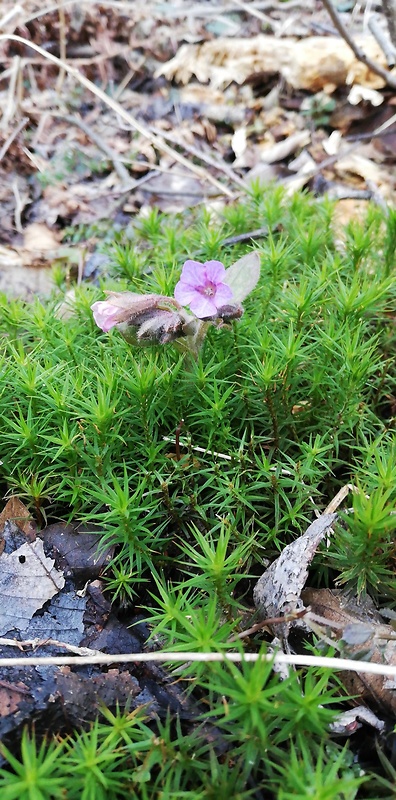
[91,252,260,357]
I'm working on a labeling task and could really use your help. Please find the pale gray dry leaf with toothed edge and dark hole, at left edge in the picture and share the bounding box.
[0,539,65,635]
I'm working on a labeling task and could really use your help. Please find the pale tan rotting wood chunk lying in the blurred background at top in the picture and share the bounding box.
[156,35,392,92]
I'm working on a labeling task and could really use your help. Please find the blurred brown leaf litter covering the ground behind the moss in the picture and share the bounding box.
[0,0,395,296]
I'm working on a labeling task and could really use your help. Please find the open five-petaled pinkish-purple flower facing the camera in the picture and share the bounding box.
[175,260,233,319]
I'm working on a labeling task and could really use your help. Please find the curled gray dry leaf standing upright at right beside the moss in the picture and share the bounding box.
[253,514,337,628]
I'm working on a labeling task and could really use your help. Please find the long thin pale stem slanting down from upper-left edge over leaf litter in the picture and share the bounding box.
[0,34,235,199]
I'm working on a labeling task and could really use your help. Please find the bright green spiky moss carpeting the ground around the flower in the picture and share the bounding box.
[0,187,396,800]
